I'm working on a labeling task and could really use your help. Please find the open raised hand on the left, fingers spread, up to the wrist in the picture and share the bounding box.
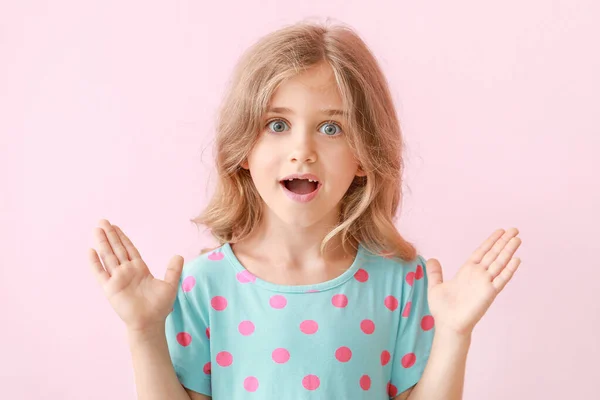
[88,219,183,331]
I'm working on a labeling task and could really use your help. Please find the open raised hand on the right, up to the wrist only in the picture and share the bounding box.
[426,228,521,335]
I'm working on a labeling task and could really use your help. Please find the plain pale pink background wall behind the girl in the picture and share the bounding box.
[0,0,600,400]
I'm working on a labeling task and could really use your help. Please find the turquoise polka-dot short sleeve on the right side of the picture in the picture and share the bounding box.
[388,255,435,398]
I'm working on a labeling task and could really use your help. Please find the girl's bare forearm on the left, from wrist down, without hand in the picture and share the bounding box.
[127,326,198,400]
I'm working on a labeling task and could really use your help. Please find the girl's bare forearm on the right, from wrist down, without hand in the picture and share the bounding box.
[401,330,471,400]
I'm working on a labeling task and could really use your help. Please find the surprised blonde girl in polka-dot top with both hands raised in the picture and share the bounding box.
[90,19,520,400]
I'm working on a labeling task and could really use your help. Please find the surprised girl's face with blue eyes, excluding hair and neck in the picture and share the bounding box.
[242,63,364,227]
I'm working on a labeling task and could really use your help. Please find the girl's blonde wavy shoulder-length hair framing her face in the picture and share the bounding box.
[191,21,417,261]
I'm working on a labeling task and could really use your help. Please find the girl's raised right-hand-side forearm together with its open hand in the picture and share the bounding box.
[408,228,521,400]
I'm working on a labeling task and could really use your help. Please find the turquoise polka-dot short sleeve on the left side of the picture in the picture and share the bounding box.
[165,270,211,396]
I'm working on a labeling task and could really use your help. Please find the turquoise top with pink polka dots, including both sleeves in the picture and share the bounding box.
[165,243,435,400]
